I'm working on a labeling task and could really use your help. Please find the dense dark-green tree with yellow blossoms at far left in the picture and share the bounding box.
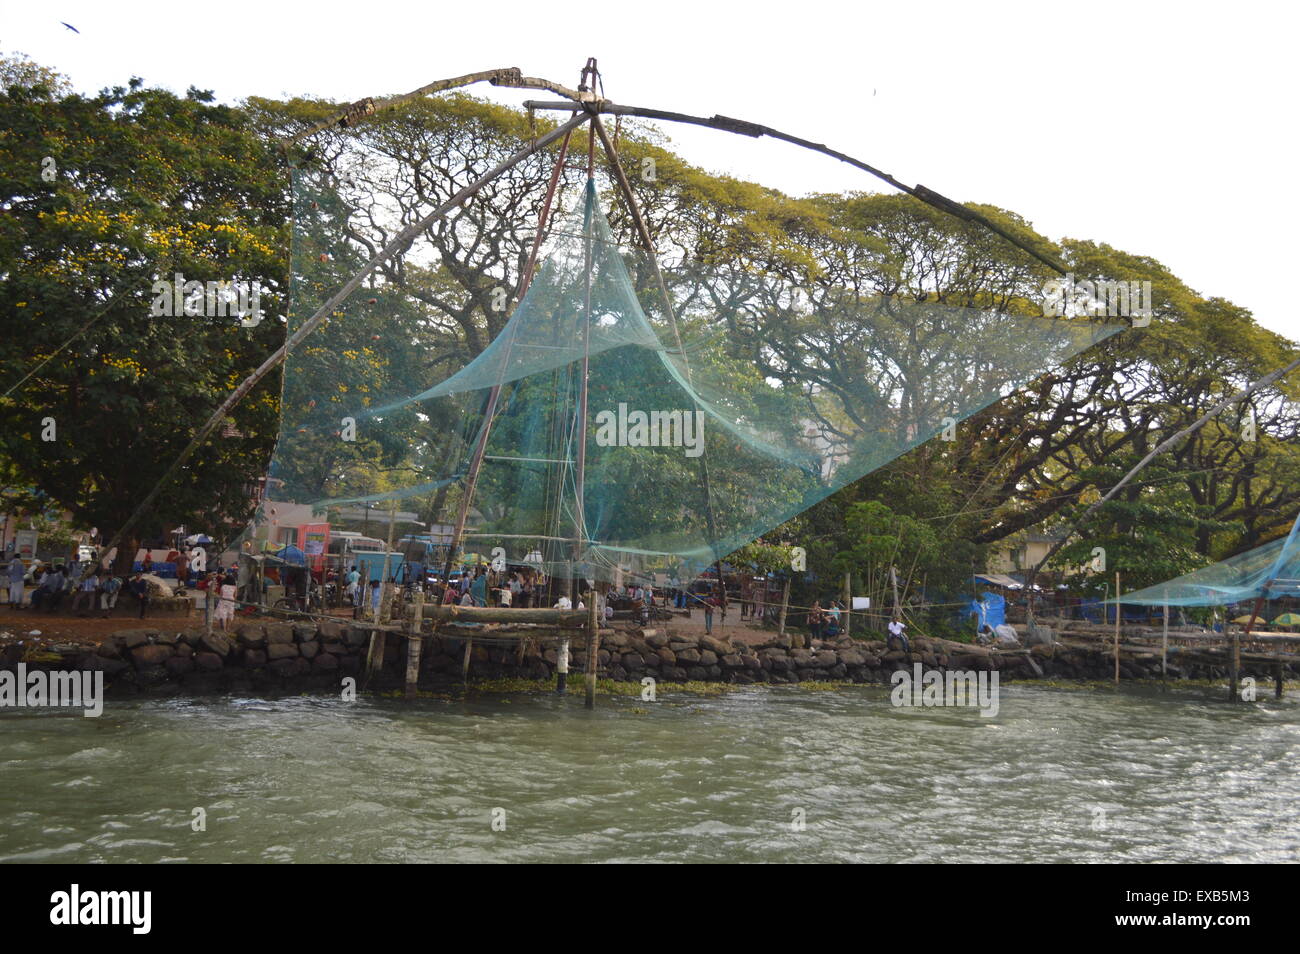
[0,65,287,574]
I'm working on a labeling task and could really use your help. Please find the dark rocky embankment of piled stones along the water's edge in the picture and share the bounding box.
[0,620,1294,693]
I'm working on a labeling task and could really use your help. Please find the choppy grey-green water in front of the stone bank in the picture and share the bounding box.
[0,685,1300,862]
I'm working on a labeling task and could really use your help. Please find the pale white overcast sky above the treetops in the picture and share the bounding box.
[0,0,1300,341]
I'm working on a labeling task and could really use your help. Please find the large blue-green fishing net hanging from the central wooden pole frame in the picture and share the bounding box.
[248,155,1123,580]
